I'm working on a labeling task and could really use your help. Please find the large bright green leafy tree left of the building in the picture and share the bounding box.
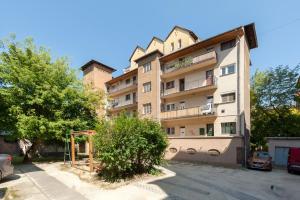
[0,36,103,160]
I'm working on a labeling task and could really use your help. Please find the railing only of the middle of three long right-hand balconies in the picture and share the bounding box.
[161,76,217,96]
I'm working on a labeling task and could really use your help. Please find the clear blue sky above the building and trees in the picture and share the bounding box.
[0,0,300,76]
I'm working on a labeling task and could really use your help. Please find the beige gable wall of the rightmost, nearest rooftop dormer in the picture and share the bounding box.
[164,28,195,54]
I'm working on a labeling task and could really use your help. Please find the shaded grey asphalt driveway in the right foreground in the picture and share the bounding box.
[151,163,300,200]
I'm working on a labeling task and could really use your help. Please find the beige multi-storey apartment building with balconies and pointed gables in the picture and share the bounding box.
[82,24,257,165]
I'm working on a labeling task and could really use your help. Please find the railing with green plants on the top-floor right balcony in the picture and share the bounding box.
[163,51,217,73]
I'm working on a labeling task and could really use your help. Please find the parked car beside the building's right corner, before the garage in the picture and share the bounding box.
[248,151,272,171]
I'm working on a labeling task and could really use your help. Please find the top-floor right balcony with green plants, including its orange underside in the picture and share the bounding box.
[161,51,217,79]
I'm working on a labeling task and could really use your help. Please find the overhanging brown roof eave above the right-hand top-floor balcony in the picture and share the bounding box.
[160,23,258,62]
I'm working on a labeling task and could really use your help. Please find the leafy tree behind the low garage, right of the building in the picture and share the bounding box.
[251,66,300,145]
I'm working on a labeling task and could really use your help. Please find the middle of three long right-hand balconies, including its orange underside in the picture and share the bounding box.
[161,77,217,99]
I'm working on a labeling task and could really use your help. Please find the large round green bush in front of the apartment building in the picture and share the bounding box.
[94,115,167,181]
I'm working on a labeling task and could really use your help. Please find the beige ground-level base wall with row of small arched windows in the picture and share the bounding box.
[165,137,244,166]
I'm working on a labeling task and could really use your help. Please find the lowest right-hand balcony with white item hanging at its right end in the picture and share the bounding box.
[160,103,217,121]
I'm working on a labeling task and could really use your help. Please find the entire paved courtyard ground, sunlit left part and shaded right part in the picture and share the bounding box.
[0,163,300,200]
